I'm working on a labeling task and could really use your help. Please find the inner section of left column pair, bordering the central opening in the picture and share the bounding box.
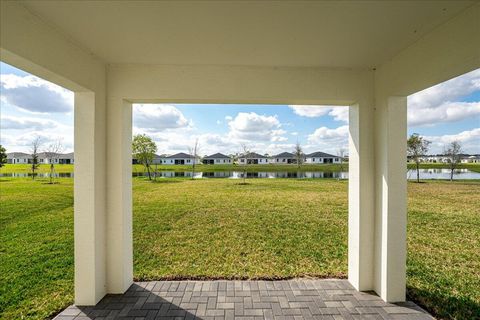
[106,98,133,293]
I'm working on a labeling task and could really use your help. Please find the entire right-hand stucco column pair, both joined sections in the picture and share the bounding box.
[348,97,407,302]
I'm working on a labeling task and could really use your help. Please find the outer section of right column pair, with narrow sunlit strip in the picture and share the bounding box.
[374,97,407,302]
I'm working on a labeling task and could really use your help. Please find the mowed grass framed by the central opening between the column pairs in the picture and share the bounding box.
[133,179,347,280]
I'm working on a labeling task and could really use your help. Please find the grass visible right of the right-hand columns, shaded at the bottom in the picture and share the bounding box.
[407,181,480,319]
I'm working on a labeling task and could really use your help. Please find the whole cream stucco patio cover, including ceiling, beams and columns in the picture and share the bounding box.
[0,1,480,305]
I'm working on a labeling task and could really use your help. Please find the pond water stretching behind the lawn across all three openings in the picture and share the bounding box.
[0,169,480,180]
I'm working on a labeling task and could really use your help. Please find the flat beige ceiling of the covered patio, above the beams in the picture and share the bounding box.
[22,1,473,68]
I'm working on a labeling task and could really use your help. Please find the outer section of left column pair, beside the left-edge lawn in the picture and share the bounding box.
[74,92,106,305]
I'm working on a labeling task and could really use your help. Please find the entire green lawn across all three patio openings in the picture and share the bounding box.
[0,178,480,319]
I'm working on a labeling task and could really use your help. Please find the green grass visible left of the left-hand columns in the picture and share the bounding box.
[0,179,74,319]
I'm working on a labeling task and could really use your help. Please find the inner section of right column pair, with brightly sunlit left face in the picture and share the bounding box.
[348,102,375,291]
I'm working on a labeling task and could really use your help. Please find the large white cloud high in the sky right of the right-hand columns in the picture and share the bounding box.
[408,69,480,126]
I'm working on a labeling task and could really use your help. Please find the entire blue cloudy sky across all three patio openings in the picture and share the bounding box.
[0,62,480,155]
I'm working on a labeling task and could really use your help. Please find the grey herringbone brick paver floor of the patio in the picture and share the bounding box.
[55,279,433,320]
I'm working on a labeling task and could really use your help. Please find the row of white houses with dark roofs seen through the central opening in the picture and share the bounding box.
[143,152,342,165]
